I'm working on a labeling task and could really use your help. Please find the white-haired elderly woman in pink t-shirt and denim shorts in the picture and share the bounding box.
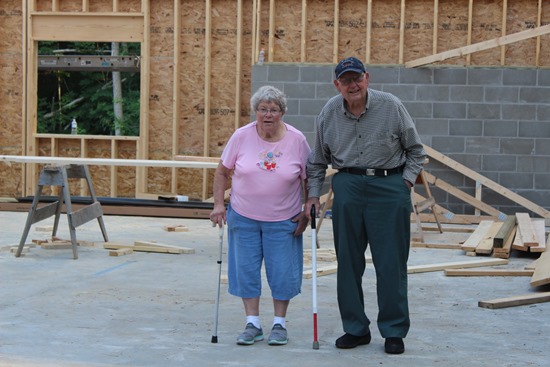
[210,86,310,345]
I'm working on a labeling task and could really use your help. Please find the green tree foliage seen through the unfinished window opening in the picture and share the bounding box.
[37,42,140,136]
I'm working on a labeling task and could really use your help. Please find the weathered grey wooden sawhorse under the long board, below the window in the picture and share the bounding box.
[15,164,109,259]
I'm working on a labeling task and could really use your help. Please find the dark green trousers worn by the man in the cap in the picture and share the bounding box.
[332,173,412,338]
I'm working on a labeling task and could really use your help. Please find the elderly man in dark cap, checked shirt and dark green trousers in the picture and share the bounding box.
[305,57,426,354]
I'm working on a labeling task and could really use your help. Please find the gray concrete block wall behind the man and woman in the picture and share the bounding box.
[252,63,550,216]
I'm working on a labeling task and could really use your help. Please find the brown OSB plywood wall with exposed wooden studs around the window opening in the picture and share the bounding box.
[0,0,550,198]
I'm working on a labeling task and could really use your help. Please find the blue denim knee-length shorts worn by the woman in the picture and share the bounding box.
[227,206,304,301]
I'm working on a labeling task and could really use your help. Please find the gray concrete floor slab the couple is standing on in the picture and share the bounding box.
[0,212,550,367]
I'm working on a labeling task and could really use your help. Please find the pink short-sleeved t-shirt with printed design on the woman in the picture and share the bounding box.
[221,121,310,222]
